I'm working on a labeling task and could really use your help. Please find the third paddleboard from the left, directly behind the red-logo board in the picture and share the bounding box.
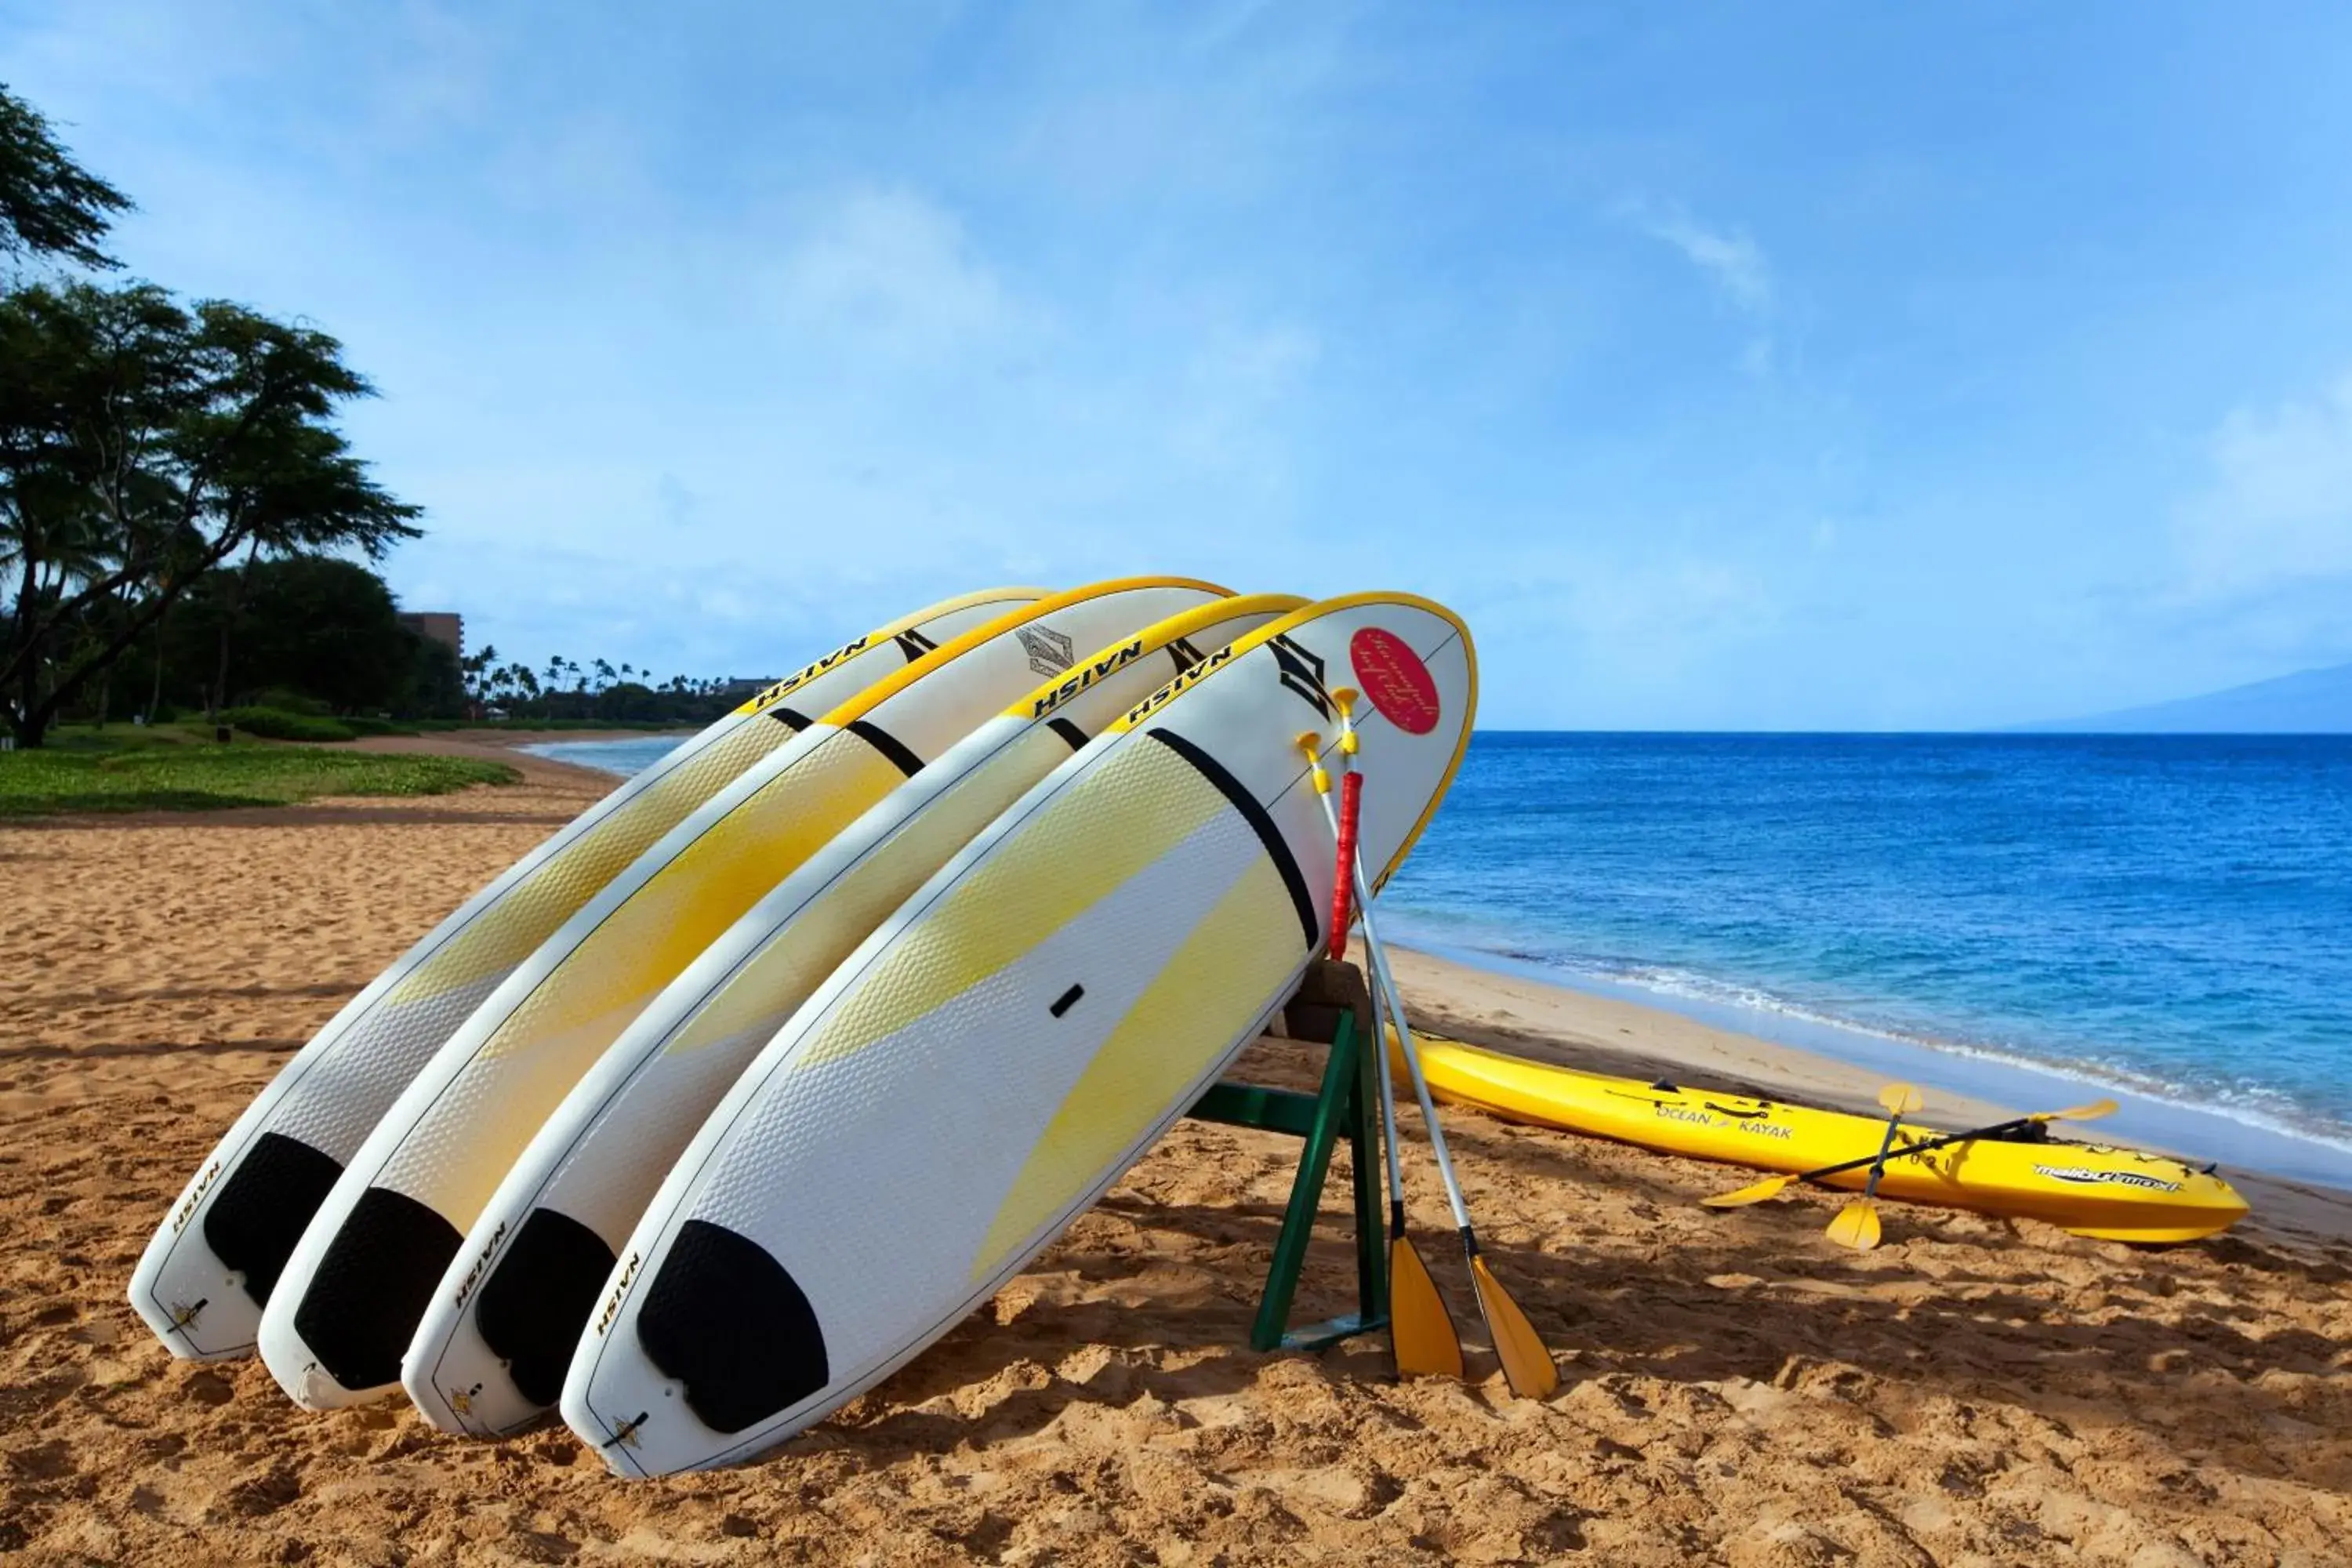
[402,595,1305,1436]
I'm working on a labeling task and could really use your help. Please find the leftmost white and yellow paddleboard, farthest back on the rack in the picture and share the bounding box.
[129,588,1047,1356]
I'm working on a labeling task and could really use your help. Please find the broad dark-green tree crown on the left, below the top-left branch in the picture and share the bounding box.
[0,282,419,746]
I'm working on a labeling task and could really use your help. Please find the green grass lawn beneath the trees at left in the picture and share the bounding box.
[0,727,522,818]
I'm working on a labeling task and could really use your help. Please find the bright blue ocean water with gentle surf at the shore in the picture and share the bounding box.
[539,731,2352,1182]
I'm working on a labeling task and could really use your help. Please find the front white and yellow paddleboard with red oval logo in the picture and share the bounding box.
[562,595,1475,1474]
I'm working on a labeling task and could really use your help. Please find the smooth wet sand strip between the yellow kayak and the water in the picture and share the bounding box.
[1392,945,2352,1241]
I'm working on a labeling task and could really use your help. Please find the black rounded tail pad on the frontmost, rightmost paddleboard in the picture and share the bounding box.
[637,1220,833,1434]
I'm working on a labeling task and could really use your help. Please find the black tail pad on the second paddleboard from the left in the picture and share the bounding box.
[287,1187,466,1403]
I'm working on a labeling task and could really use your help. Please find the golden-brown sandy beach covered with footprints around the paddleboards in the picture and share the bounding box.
[0,752,2352,1568]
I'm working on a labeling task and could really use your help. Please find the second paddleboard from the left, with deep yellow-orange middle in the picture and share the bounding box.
[261,579,1225,1408]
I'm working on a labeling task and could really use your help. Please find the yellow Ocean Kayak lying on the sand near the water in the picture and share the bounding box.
[1399,1029,2246,1241]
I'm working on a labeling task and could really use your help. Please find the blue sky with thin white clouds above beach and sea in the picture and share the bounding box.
[0,0,2352,729]
